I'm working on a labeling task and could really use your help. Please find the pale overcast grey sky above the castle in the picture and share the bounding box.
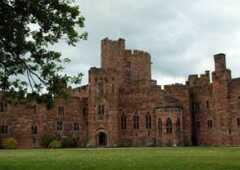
[56,0,240,85]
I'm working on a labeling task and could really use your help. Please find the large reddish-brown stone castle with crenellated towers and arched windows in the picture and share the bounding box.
[0,38,240,148]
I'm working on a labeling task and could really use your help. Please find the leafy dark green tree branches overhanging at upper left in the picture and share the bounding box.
[0,0,87,98]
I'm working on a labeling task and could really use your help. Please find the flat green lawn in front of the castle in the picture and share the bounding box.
[0,147,240,170]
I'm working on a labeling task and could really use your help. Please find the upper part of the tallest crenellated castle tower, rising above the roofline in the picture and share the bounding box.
[101,38,151,82]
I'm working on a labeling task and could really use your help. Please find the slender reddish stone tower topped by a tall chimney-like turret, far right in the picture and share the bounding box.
[212,53,232,145]
